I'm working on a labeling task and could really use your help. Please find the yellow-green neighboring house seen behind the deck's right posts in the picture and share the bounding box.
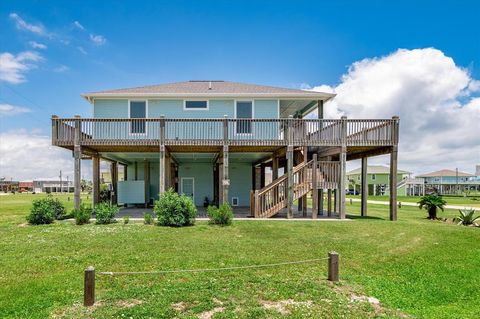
[347,165,411,196]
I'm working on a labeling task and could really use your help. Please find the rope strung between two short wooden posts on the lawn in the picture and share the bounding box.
[83,251,339,306]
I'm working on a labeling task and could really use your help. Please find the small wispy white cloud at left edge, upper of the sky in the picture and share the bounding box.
[0,51,43,84]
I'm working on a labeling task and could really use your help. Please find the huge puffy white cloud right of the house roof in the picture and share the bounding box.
[313,48,480,173]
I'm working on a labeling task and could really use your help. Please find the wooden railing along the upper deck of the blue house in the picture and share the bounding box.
[52,116,398,146]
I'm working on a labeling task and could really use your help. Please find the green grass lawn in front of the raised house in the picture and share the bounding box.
[0,195,480,318]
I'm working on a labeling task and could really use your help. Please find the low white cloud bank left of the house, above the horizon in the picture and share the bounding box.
[0,130,91,180]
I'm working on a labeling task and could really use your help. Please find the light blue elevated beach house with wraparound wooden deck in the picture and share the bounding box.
[52,81,399,220]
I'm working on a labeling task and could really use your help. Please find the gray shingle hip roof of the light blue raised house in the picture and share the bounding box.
[82,80,335,100]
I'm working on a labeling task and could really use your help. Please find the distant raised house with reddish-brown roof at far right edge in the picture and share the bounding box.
[417,170,480,195]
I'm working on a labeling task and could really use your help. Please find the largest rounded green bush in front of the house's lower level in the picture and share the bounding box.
[154,189,197,227]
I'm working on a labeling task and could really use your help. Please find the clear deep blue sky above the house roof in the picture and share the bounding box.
[0,1,480,179]
